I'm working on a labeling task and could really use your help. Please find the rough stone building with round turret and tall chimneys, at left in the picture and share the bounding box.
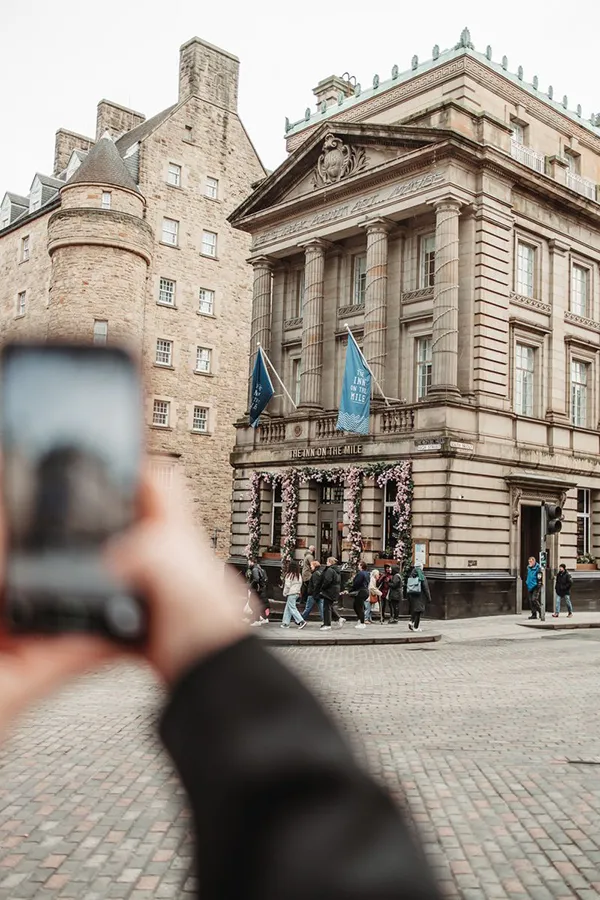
[0,38,265,553]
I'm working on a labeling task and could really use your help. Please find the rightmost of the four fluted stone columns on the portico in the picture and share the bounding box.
[429,197,461,397]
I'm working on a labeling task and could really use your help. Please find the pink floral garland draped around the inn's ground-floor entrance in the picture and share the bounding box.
[244,460,414,573]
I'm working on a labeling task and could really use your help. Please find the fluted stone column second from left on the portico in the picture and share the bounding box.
[300,238,329,408]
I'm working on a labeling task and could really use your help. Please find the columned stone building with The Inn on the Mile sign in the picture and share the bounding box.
[231,30,600,617]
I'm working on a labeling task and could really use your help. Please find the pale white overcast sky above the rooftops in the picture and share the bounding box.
[0,0,600,198]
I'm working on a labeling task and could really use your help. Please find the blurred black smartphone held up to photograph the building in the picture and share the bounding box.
[0,343,147,643]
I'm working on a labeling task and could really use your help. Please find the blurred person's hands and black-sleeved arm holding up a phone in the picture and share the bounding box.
[0,468,441,900]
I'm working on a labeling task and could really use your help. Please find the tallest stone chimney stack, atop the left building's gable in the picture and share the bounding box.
[179,37,240,112]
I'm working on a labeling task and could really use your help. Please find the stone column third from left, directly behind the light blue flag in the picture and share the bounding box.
[363,219,391,396]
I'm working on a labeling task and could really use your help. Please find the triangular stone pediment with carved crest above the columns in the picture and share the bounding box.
[230,122,447,224]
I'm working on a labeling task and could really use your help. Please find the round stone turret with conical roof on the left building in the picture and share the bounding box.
[48,137,153,351]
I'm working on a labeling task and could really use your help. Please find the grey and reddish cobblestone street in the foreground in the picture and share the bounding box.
[0,619,600,900]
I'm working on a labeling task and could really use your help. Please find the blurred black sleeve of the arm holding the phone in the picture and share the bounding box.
[161,638,440,900]
